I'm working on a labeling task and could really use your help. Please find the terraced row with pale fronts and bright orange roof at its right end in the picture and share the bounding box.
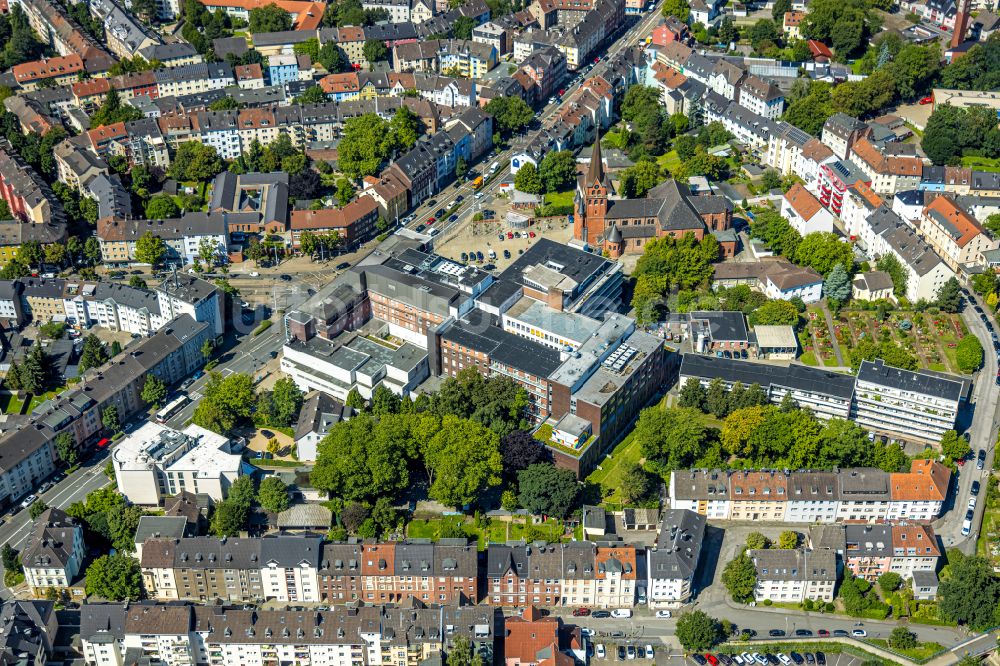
[670,460,951,523]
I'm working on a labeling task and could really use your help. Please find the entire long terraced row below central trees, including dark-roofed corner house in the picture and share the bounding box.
[138,508,705,608]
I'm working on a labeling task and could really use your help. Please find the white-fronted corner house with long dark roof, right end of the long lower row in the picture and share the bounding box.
[646,509,706,607]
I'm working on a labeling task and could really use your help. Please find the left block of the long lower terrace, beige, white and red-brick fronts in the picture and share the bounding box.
[140,536,480,606]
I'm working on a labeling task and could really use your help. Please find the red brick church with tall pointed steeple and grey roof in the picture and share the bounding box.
[573,136,736,258]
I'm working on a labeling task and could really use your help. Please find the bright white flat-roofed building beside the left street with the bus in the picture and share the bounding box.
[111,421,243,506]
